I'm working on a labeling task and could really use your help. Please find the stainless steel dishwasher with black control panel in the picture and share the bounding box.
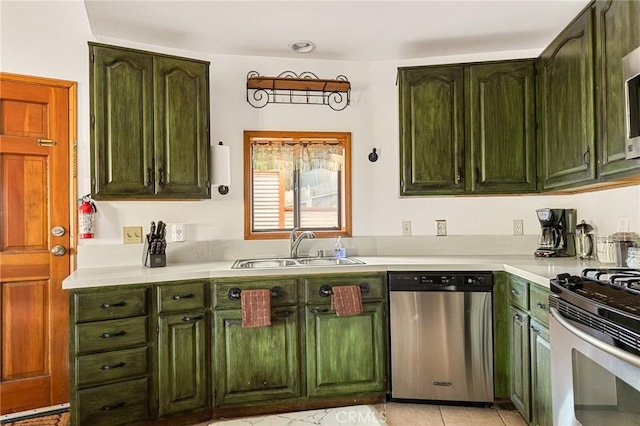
[388,271,494,403]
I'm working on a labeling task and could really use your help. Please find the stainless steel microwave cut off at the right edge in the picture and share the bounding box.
[622,47,640,159]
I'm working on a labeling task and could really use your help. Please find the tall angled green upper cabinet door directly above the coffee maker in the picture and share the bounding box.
[538,9,596,190]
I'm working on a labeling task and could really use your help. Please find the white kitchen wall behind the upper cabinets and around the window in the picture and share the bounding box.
[0,0,640,250]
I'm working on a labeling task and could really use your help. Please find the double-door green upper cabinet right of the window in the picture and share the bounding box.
[399,60,537,196]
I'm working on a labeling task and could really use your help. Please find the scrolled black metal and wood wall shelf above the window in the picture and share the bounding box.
[247,71,351,111]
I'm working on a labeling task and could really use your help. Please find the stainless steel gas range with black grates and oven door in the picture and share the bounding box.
[549,268,640,426]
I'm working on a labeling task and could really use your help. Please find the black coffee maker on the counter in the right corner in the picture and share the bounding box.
[534,209,576,257]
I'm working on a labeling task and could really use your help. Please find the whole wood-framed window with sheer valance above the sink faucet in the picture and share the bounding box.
[244,131,351,239]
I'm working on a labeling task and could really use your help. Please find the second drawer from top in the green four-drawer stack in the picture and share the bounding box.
[74,317,148,353]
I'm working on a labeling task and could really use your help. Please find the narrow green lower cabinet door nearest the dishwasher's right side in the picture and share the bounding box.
[509,306,531,422]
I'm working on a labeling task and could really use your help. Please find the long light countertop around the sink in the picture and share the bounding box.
[62,255,601,289]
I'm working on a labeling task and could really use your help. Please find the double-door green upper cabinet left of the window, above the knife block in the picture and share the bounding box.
[89,43,210,199]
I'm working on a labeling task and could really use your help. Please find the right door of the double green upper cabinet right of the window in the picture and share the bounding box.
[466,61,537,193]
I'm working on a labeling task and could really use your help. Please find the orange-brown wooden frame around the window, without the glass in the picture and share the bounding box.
[243,130,352,240]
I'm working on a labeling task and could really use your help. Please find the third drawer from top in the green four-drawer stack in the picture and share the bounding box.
[76,347,148,387]
